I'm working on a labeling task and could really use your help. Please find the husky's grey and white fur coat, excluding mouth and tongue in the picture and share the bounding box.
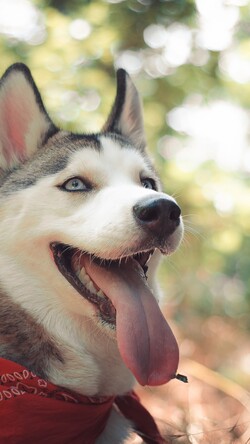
[0,64,183,444]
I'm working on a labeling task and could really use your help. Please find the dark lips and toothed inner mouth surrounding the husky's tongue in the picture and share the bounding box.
[50,242,154,329]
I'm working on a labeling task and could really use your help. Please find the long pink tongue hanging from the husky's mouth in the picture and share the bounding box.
[82,256,179,385]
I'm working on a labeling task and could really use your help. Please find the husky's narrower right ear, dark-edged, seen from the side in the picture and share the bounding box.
[103,69,146,150]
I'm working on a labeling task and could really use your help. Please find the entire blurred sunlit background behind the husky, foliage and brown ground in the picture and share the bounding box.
[0,0,250,444]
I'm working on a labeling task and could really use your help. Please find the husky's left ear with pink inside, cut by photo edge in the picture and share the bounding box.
[0,63,56,170]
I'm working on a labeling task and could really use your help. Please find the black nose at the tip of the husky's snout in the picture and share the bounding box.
[133,197,181,236]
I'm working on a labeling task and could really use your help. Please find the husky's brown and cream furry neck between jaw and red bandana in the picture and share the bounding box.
[0,284,134,396]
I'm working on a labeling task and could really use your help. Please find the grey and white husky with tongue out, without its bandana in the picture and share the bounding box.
[0,63,183,444]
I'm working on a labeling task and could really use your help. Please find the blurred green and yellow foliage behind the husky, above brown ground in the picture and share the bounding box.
[0,0,250,336]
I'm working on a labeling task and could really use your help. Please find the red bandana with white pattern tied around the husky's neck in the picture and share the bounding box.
[0,358,166,444]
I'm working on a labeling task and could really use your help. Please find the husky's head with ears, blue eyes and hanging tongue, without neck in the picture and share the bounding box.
[0,64,183,385]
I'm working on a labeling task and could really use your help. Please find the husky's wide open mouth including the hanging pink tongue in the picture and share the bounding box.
[50,242,179,385]
